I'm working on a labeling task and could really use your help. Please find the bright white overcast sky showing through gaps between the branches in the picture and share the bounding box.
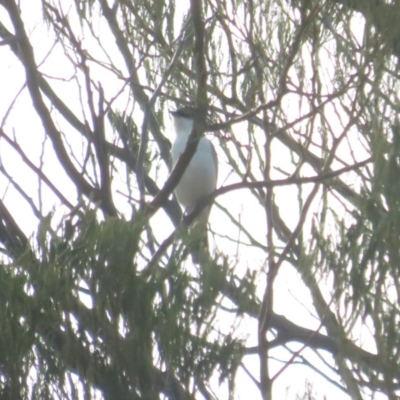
[0,0,383,400]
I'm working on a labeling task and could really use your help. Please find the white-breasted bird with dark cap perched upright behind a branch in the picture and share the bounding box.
[170,107,218,264]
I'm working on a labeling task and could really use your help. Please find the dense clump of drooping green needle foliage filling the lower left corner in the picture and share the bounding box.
[0,210,242,398]
